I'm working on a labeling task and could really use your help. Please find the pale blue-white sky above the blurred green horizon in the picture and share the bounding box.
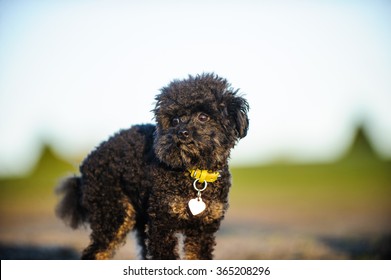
[0,0,391,176]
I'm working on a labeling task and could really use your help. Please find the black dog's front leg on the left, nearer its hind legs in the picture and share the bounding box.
[146,220,179,260]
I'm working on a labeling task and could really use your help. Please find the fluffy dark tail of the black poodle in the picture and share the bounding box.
[56,176,87,229]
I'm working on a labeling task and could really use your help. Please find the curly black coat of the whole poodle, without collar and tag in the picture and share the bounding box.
[57,74,249,259]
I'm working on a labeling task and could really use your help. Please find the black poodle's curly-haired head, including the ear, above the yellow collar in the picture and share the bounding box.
[154,74,249,170]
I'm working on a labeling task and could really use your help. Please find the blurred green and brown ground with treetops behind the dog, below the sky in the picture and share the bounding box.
[0,128,391,259]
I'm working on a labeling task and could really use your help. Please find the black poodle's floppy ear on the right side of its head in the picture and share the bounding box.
[220,91,249,139]
